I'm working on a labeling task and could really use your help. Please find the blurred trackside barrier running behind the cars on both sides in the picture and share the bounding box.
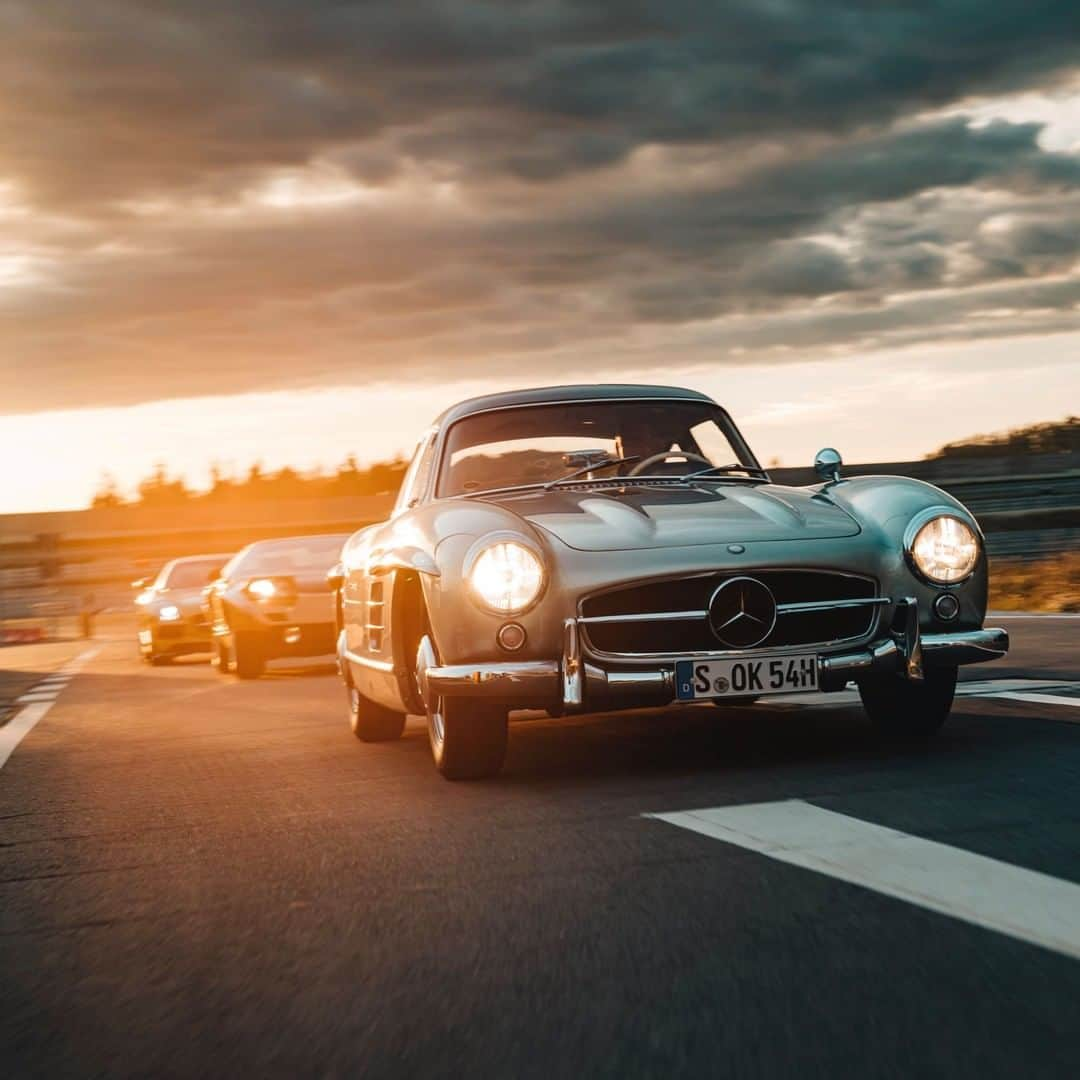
[0,455,1080,629]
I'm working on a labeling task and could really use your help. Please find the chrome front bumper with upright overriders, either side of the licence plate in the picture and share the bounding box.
[424,599,1009,711]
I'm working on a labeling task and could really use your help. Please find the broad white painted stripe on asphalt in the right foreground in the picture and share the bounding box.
[646,799,1080,959]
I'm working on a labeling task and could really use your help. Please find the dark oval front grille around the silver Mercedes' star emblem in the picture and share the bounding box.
[580,570,880,657]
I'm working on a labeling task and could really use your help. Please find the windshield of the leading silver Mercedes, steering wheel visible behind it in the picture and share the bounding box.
[437,400,755,496]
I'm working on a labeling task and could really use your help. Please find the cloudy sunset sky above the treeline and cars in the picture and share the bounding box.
[0,0,1080,512]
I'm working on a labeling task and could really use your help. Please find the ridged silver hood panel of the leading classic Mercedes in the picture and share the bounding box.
[489,484,860,551]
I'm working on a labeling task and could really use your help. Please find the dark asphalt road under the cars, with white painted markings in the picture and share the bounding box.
[0,618,1080,1078]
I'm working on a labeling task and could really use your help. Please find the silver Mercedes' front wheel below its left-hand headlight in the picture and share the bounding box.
[416,635,508,780]
